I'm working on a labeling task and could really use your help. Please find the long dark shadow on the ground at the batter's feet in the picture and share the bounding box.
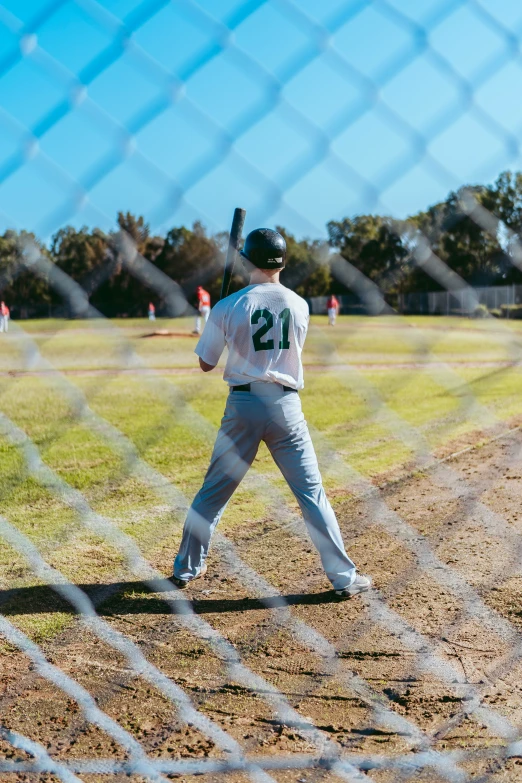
[0,582,342,616]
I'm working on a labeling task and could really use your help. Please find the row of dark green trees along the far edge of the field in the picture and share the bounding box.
[0,171,522,317]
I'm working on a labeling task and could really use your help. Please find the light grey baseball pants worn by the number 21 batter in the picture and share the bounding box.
[174,382,356,590]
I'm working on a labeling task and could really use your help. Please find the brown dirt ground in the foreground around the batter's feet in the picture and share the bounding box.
[0,431,522,783]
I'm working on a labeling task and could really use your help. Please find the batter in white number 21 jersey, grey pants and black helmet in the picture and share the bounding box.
[173,228,371,597]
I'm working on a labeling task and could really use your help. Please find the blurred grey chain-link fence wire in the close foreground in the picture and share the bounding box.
[5,0,522,783]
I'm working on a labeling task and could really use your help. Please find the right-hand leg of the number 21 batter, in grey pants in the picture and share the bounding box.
[263,392,357,590]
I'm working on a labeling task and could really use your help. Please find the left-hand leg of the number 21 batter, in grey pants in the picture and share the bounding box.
[174,392,264,582]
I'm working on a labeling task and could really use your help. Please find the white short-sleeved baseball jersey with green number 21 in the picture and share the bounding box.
[195,283,310,389]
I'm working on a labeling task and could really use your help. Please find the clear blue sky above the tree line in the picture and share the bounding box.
[0,0,522,238]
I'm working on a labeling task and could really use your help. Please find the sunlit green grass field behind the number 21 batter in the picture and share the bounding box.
[0,317,522,639]
